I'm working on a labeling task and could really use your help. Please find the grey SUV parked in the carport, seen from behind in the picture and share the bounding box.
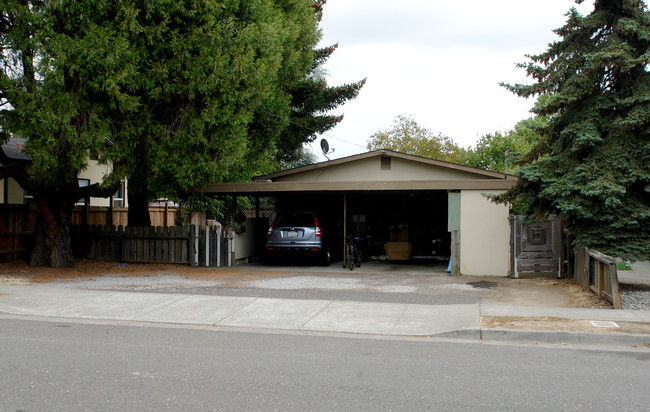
[266,212,331,265]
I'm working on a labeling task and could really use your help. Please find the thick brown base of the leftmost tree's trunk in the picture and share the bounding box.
[29,205,74,268]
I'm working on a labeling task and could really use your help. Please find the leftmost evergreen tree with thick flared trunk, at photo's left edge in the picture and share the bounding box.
[0,0,136,267]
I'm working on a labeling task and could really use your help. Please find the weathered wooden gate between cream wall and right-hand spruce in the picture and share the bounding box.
[509,216,564,278]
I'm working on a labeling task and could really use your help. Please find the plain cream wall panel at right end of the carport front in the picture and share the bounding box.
[460,190,510,277]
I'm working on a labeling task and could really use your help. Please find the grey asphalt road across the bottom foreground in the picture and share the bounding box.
[0,319,650,411]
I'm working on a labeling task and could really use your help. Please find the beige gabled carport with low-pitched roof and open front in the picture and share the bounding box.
[192,150,516,276]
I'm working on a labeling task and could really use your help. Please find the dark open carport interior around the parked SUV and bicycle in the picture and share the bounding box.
[275,190,450,263]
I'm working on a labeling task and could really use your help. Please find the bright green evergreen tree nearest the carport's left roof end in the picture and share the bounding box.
[125,0,317,226]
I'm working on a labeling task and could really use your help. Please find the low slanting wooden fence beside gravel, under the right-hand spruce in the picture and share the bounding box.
[573,248,621,309]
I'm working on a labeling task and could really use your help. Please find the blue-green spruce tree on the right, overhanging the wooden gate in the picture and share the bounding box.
[498,0,650,259]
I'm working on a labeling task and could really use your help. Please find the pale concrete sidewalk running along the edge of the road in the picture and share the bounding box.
[0,285,650,346]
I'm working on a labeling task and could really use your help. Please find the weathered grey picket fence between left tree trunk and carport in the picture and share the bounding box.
[71,225,234,266]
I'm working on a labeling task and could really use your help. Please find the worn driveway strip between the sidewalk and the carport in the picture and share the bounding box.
[0,261,607,308]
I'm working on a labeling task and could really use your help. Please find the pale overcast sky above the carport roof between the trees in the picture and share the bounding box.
[312,0,647,160]
